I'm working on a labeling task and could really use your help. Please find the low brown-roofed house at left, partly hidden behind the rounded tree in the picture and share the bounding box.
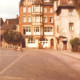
[1,18,19,48]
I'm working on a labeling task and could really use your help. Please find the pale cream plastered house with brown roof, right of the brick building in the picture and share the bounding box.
[54,0,80,50]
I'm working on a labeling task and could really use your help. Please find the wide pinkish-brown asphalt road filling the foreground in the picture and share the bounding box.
[0,49,80,80]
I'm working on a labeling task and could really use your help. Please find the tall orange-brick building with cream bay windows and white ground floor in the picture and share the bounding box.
[19,0,55,49]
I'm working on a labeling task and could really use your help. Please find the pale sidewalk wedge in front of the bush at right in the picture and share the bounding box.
[60,51,80,60]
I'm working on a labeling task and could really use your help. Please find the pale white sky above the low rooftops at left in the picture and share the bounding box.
[0,0,20,20]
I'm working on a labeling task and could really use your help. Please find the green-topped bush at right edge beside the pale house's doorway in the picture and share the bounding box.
[70,38,80,52]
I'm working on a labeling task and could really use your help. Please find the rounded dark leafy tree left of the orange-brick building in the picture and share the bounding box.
[4,31,23,45]
